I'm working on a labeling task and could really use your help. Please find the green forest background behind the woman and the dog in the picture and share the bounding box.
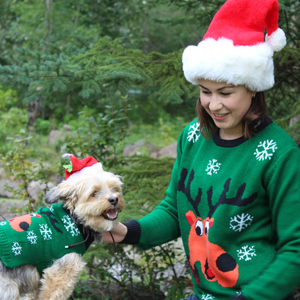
[0,0,300,300]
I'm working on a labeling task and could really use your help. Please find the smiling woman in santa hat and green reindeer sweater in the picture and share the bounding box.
[104,0,300,300]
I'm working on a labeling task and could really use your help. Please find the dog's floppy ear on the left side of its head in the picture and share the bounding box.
[45,181,77,204]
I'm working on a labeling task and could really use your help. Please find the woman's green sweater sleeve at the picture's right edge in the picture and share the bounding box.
[242,147,300,300]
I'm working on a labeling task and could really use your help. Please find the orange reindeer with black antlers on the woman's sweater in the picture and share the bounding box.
[178,168,257,287]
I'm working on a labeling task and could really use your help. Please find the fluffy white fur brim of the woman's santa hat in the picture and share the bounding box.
[182,35,274,92]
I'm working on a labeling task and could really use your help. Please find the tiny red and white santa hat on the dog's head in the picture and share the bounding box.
[63,153,103,181]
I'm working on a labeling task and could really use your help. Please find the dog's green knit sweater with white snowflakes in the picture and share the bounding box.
[0,204,86,275]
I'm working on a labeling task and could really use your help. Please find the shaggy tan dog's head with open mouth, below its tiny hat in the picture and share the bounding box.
[45,164,125,232]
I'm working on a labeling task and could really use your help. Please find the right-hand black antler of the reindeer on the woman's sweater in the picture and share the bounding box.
[207,178,258,217]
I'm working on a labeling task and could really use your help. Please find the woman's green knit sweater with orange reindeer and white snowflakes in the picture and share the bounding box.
[138,119,300,300]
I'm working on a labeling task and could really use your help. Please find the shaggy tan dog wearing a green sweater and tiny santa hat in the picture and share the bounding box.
[0,156,125,300]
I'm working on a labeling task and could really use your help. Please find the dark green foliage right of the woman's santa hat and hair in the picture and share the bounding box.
[267,0,300,139]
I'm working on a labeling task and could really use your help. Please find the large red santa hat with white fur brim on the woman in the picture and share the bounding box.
[182,0,286,92]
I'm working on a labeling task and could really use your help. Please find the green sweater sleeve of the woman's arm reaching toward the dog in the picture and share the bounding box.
[137,133,183,250]
